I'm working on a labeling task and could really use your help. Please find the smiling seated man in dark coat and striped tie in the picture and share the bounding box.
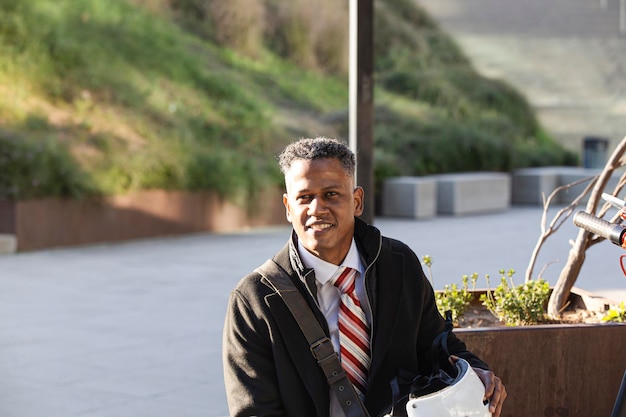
[223,138,506,417]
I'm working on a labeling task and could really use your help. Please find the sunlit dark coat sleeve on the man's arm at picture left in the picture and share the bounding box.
[222,289,286,417]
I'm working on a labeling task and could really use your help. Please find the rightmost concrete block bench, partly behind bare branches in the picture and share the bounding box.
[511,166,621,205]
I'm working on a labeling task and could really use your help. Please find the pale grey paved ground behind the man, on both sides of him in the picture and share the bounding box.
[0,207,626,417]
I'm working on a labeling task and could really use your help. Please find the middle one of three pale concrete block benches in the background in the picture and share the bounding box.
[433,172,511,215]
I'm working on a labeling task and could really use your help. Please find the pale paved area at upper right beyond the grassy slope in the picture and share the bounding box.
[418,0,626,151]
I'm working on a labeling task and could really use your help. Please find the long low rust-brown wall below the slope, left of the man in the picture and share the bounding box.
[0,190,287,251]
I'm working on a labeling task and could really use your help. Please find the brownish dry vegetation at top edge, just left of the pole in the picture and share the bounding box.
[165,0,349,74]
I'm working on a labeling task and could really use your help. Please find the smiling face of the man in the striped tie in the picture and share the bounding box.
[283,158,363,265]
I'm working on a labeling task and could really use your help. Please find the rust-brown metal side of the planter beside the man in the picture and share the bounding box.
[455,324,626,417]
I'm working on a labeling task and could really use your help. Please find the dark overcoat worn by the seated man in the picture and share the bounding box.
[223,219,488,417]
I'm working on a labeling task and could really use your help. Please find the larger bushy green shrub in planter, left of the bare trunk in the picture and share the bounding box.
[481,269,550,326]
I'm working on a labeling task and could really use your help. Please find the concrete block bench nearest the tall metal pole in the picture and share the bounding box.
[382,176,437,219]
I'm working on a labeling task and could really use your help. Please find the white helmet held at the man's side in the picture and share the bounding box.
[406,358,491,417]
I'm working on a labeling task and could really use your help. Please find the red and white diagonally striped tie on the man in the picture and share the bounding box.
[333,267,371,397]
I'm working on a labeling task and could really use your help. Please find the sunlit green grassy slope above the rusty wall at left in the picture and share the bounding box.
[0,0,292,199]
